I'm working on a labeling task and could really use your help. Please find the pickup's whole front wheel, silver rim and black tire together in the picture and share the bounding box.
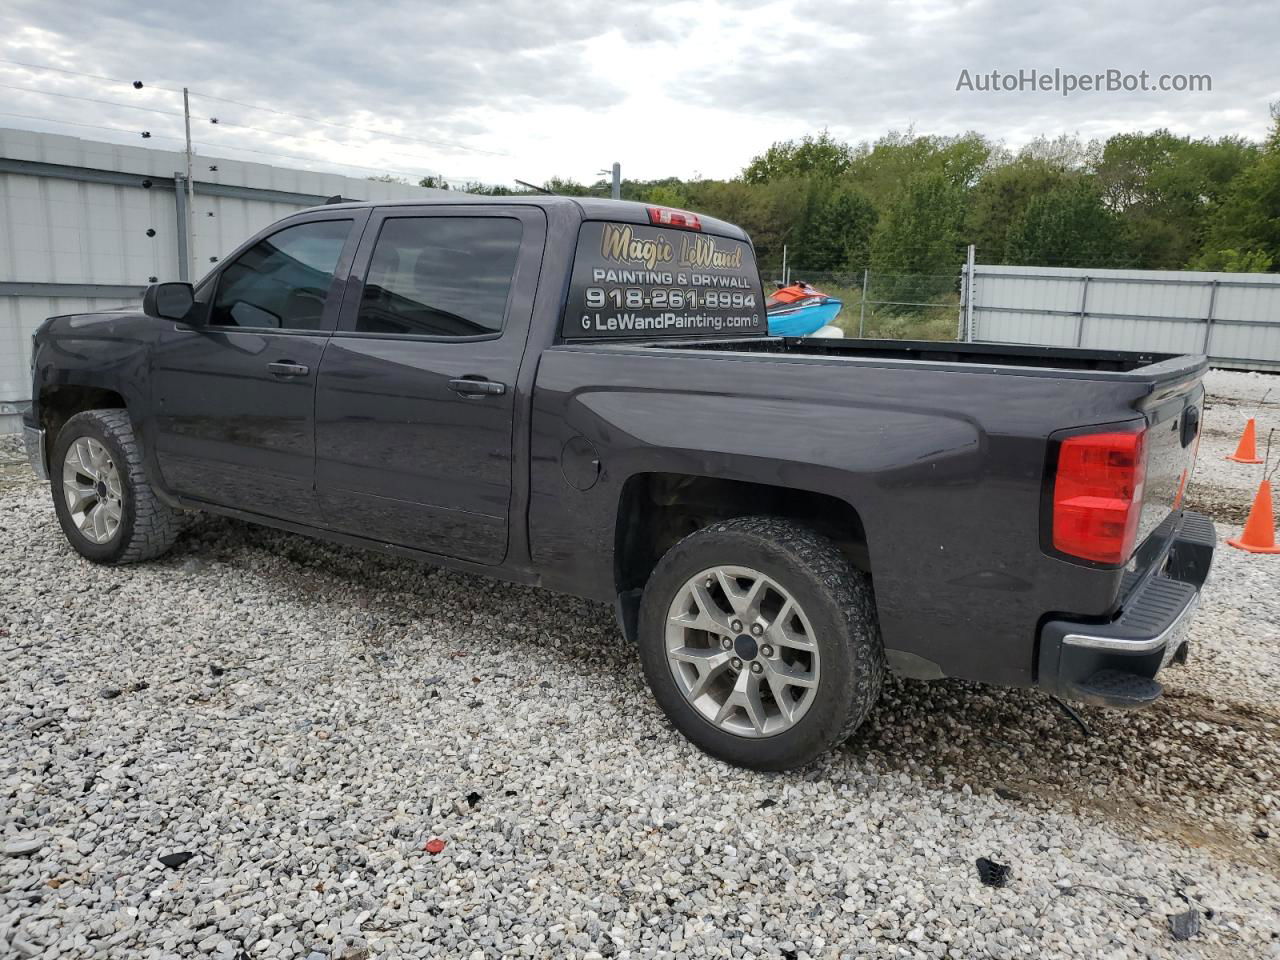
[49,410,183,564]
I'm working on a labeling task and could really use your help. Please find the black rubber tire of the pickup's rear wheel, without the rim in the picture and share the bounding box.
[639,516,884,771]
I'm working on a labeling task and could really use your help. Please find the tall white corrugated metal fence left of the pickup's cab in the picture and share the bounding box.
[0,129,450,433]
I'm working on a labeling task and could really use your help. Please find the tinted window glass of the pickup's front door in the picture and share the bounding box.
[209,220,351,330]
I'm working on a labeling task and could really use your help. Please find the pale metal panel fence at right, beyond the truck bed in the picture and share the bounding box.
[960,264,1280,370]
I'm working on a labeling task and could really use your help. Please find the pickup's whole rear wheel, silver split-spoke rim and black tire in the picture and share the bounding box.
[640,517,884,771]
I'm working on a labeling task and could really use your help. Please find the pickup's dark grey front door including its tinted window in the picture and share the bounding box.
[151,211,367,524]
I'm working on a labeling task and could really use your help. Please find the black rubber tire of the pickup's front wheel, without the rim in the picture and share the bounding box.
[49,410,183,564]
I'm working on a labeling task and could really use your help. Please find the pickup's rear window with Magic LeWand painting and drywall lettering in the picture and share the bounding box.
[561,221,768,340]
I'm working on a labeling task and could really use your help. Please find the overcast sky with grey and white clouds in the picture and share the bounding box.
[0,0,1280,183]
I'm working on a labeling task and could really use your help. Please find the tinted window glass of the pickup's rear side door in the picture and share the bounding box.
[356,216,524,337]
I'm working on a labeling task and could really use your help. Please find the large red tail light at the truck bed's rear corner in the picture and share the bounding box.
[1053,433,1146,564]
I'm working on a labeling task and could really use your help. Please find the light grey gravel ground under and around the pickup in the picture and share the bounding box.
[0,372,1280,960]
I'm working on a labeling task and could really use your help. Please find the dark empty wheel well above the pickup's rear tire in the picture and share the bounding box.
[613,474,870,594]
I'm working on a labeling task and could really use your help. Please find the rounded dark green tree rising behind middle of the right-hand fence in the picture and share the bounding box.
[1005,180,1121,266]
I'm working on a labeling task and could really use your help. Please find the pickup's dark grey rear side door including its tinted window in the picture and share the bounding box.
[316,205,547,564]
